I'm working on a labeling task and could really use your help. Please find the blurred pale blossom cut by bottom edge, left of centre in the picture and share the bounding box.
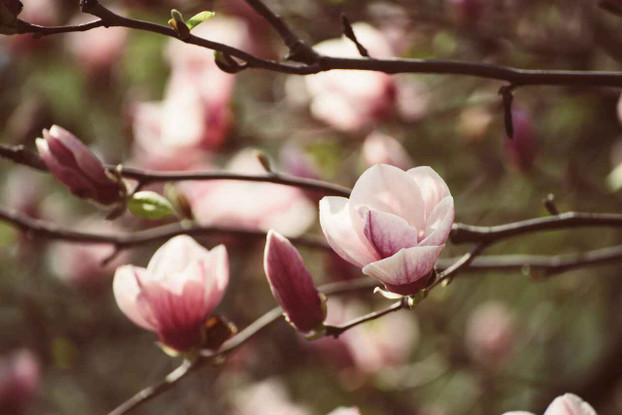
[233,378,311,415]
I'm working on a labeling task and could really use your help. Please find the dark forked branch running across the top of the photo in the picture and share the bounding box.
[6,0,622,87]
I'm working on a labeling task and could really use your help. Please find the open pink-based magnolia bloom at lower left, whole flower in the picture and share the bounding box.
[113,235,229,352]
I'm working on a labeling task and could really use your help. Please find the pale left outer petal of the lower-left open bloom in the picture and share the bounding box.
[112,265,156,331]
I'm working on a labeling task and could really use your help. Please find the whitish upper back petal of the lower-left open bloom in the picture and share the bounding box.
[147,235,214,280]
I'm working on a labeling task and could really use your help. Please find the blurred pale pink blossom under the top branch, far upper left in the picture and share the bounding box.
[66,13,127,75]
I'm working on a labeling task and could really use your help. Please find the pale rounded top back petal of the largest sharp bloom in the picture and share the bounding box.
[350,164,425,233]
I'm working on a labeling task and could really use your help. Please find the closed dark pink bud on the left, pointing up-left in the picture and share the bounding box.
[36,125,123,205]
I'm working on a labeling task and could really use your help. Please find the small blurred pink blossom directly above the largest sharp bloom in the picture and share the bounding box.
[361,132,413,169]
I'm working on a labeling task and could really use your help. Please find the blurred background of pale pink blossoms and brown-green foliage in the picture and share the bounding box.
[0,0,622,415]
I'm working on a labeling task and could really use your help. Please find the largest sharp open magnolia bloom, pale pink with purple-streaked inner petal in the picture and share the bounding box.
[320,164,454,295]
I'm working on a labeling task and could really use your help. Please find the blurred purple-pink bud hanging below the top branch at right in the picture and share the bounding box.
[504,106,536,171]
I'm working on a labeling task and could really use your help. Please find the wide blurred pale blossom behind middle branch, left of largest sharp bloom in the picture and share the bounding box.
[179,149,316,236]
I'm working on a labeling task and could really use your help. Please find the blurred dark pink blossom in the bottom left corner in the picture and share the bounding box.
[0,350,40,415]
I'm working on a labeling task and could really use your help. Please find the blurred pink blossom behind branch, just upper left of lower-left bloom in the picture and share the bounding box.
[49,219,129,287]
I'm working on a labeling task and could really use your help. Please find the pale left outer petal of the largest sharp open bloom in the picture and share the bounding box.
[320,196,378,267]
